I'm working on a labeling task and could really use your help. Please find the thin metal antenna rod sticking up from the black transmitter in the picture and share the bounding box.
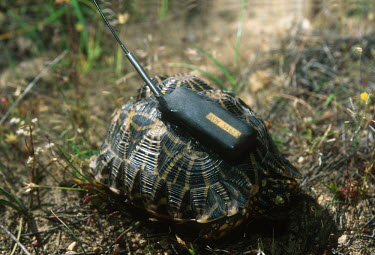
[92,0,161,97]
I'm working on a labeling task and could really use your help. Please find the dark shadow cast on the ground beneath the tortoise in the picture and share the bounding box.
[94,190,338,255]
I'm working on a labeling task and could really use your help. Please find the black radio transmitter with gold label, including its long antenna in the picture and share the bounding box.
[92,0,257,161]
